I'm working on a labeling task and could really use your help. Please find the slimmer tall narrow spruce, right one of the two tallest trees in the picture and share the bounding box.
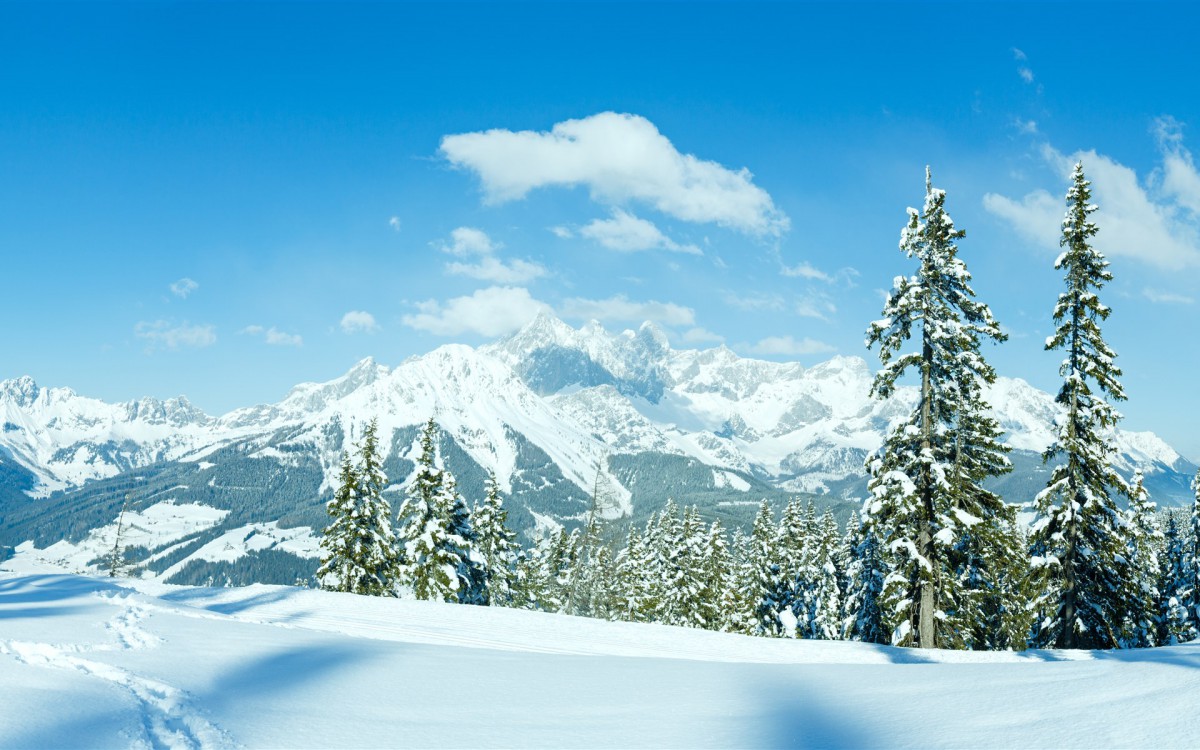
[1031,163,1130,648]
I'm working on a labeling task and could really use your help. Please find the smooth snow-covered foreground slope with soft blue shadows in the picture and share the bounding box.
[0,571,1200,748]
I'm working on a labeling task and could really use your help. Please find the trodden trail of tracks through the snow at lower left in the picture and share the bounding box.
[0,593,238,750]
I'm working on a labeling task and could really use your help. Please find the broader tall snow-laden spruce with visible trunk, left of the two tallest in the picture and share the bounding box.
[864,169,1008,648]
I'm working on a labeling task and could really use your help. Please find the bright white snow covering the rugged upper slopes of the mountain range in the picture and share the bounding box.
[0,316,1195,518]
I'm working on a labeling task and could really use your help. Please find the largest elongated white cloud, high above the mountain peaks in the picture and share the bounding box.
[440,112,788,236]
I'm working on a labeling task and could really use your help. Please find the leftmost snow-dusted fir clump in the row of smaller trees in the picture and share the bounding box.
[317,420,400,596]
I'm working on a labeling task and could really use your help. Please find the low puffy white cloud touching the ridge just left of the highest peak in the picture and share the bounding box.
[403,287,551,337]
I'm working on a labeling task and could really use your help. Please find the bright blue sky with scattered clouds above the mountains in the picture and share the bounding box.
[0,2,1200,458]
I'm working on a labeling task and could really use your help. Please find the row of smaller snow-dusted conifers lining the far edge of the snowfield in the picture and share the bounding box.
[317,410,1200,649]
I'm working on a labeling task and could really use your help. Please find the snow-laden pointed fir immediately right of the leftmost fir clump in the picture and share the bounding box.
[398,419,473,601]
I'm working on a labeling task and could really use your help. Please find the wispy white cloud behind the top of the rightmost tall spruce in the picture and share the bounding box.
[983,138,1200,270]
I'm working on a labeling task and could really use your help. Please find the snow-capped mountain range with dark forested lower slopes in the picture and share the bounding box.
[0,314,1195,582]
